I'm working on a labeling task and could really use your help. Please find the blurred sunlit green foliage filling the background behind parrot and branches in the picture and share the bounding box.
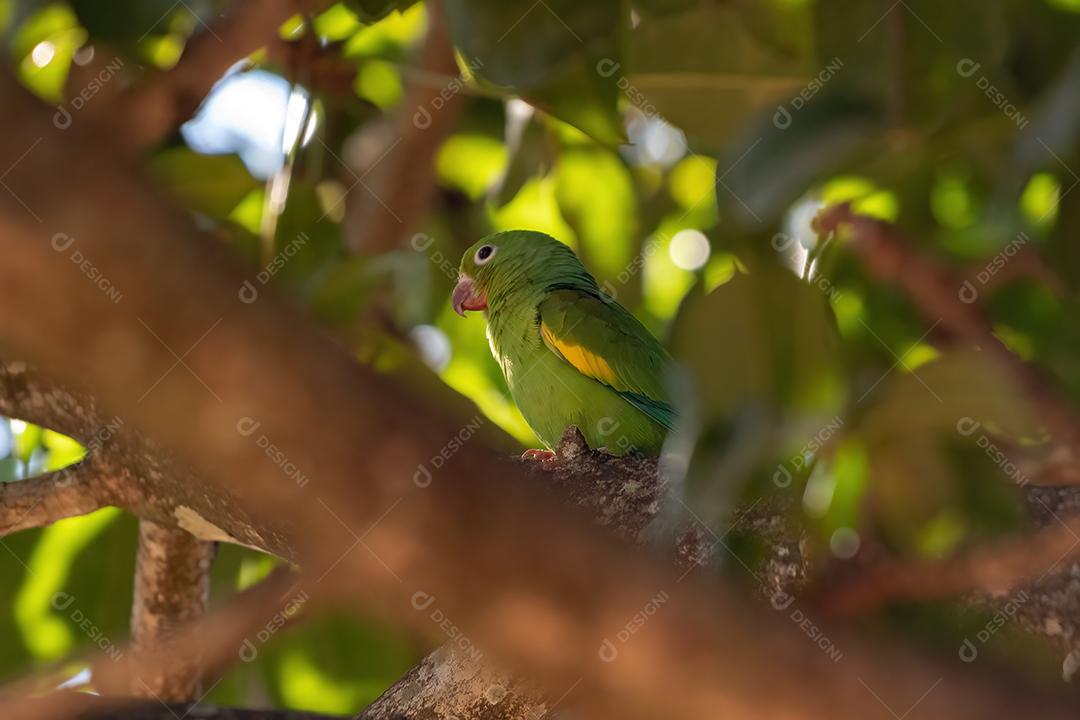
[0,0,1080,712]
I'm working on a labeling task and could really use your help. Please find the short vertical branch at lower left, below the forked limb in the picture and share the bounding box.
[132,520,214,703]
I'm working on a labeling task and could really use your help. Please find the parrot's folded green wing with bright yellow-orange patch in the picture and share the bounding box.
[538,288,675,430]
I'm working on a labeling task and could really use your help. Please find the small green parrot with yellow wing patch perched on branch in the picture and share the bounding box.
[453,230,675,460]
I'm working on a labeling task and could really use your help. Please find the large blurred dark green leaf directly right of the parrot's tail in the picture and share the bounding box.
[671,259,843,527]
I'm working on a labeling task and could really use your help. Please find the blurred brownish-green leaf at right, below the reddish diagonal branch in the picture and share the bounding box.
[855,350,1041,555]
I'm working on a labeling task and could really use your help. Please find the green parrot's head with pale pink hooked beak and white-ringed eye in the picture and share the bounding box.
[453,230,596,316]
